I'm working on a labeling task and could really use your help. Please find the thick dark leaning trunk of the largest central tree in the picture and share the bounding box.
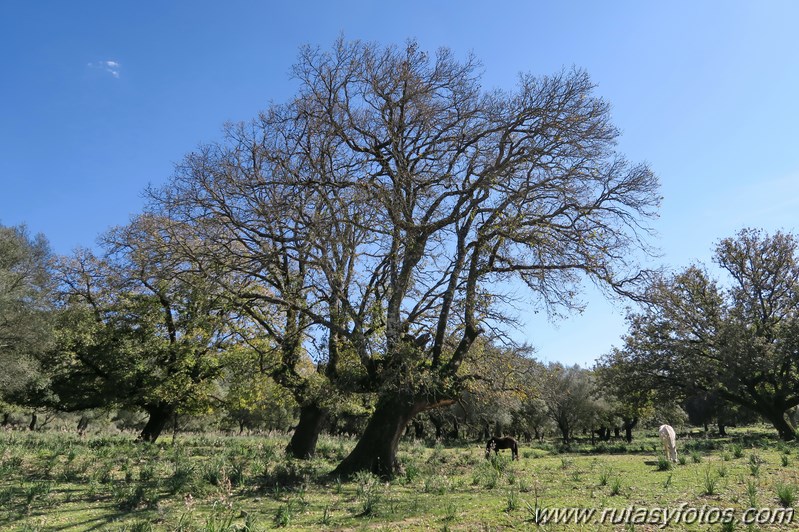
[331,397,433,478]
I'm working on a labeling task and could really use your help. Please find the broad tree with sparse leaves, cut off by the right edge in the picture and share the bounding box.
[619,229,799,440]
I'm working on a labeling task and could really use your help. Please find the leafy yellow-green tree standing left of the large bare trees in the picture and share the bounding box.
[42,216,232,441]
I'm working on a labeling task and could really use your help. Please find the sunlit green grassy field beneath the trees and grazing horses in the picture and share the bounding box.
[0,429,799,531]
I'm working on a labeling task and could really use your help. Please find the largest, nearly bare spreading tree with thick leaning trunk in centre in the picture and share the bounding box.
[153,40,660,476]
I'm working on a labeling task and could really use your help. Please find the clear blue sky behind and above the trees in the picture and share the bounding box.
[0,0,799,365]
